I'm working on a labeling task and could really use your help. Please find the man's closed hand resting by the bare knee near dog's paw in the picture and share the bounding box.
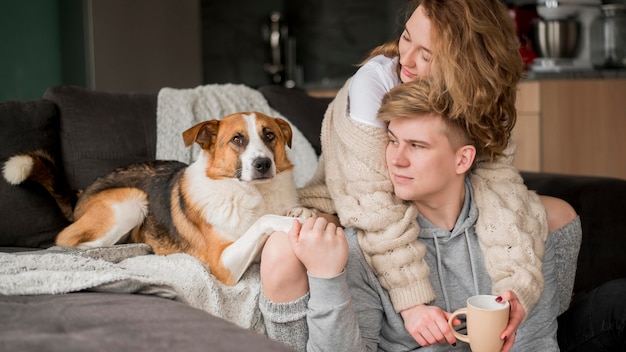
[288,217,348,278]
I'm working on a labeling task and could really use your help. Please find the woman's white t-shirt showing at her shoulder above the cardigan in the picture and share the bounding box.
[348,55,402,128]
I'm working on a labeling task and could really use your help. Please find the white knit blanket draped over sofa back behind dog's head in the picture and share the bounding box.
[156,84,317,187]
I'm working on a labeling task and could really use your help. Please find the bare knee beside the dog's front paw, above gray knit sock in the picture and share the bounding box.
[261,232,309,302]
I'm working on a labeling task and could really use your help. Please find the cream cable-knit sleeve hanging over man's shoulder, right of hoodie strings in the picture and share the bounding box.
[470,142,548,313]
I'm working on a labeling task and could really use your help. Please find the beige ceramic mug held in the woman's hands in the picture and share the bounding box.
[448,295,509,352]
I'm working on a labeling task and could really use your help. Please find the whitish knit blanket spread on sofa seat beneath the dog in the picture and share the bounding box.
[0,244,265,333]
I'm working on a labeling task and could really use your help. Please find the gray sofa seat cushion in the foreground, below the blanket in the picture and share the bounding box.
[0,292,290,352]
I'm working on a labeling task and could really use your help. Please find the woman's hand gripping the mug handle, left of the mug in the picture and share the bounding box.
[400,304,461,347]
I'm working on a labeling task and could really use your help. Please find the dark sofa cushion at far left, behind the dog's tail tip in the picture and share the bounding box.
[0,100,68,248]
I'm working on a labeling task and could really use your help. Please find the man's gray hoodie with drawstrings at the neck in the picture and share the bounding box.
[262,183,559,352]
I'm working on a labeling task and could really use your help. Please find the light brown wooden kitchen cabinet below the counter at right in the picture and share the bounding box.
[512,79,626,179]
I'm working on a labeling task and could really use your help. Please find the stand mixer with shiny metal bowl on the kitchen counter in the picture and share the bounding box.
[530,0,602,71]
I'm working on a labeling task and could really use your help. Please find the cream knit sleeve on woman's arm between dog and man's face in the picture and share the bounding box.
[310,76,434,311]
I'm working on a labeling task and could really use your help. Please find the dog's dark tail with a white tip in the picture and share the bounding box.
[2,150,78,221]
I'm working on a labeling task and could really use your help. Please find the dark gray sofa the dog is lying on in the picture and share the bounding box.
[0,85,626,351]
